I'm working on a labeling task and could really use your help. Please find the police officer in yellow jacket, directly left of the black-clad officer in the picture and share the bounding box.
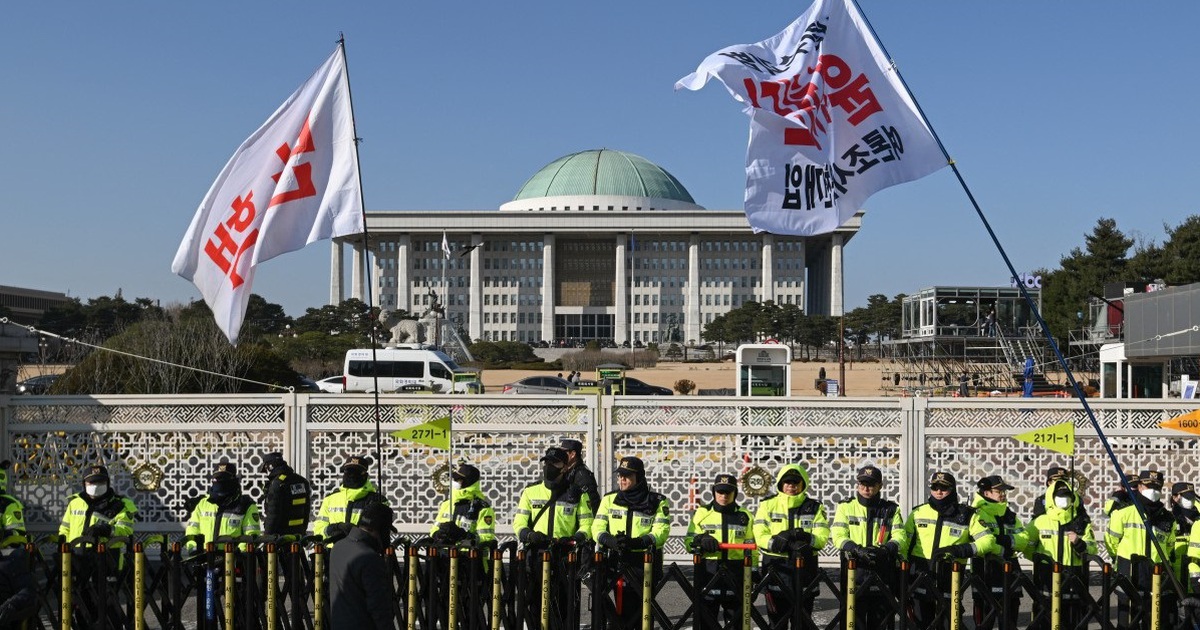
[185,462,263,552]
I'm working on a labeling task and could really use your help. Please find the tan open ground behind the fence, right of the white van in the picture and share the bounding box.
[484,361,884,396]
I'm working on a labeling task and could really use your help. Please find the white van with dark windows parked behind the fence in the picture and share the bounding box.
[342,344,484,394]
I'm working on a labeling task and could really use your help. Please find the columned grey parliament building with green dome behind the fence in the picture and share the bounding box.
[329,149,862,346]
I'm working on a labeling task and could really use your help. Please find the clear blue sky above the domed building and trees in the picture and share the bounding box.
[0,0,1200,316]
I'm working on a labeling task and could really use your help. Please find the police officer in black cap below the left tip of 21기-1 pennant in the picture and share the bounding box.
[971,475,1028,630]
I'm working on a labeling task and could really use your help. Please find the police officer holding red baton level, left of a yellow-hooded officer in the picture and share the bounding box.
[684,473,754,628]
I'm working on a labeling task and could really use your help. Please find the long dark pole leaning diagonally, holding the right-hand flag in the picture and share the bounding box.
[847,0,1186,590]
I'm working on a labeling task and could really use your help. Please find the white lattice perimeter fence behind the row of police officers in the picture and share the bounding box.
[0,394,1200,557]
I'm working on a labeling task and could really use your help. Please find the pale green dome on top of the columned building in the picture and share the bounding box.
[512,149,696,204]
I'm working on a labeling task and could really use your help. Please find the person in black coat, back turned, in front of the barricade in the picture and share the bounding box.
[329,503,396,630]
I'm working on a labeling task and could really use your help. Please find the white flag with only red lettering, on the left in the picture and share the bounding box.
[170,44,362,343]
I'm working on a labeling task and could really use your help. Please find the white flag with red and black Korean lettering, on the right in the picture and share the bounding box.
[676,0,948,236]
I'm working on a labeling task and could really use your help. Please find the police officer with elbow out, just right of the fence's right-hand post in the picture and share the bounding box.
[904,470,996,629]
